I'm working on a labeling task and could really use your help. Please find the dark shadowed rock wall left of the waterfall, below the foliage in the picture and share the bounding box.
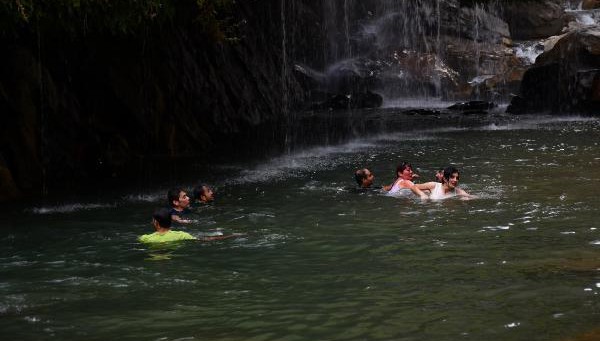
[0,1,323,200]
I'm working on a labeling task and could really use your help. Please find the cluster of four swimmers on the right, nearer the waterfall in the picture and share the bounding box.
[354,162,474,199]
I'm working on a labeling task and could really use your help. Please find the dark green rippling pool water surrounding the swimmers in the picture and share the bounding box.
[0,113,600,341]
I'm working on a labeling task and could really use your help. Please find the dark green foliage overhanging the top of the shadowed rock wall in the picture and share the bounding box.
[0,0,234,40]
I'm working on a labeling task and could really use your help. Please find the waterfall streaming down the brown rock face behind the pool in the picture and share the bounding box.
[296,0,509,107]
